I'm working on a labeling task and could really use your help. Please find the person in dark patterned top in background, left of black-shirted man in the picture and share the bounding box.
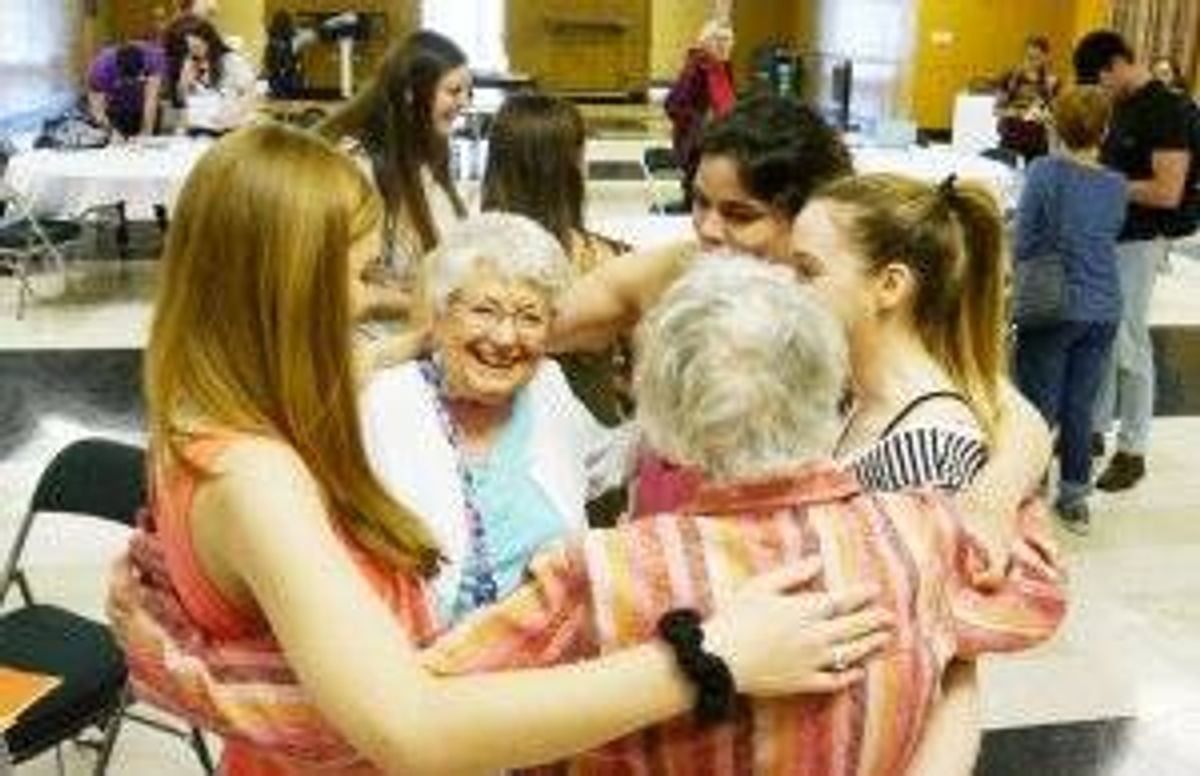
[996,35,1058,163]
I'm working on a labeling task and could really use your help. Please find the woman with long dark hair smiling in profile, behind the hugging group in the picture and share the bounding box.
[317,30,470,280]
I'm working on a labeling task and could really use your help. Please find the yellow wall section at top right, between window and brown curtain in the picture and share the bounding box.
[912,0,1093,128]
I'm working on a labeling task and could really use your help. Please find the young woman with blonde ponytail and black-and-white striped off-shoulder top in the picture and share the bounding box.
[788,174,1048,776]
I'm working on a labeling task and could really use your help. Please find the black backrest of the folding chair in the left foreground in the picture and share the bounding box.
[29,439,146,525]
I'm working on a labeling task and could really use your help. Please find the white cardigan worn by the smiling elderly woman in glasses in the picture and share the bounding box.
[361,359,634,614]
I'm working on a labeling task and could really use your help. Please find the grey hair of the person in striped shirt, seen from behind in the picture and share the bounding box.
[634,255,847,480]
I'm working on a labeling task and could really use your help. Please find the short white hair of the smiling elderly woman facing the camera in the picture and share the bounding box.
[426,211,571,312]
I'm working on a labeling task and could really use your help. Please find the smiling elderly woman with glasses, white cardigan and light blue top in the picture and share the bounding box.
[362,212,626,621]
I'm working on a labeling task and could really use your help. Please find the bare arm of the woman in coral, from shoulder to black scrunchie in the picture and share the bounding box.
[193,440,689,774]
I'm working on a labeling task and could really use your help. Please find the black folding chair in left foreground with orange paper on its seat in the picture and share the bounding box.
[0,439,214,776]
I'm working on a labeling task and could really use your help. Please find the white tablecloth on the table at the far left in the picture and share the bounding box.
[5,138,211,219]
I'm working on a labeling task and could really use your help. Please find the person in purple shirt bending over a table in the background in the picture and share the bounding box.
[88,41,167,137]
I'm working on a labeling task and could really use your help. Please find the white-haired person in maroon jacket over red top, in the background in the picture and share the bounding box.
[664,19,737,211]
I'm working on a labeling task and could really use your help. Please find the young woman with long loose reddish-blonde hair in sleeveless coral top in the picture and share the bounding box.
[133,125,886,776]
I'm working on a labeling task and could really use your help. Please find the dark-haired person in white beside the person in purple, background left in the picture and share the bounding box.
[168,17,257,132]
